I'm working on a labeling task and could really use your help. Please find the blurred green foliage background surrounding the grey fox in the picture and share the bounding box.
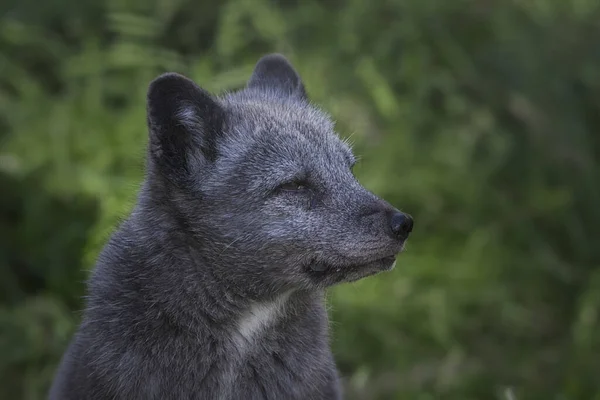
[0,0,600,400]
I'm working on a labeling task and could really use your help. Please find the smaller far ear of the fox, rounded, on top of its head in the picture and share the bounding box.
[247,53,307,100]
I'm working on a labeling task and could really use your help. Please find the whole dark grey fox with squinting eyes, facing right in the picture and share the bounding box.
[50,55,412,400]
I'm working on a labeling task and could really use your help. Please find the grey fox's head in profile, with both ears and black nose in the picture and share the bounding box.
[147,54,413,297]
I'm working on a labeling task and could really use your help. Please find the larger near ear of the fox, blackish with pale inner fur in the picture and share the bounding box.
[146,73,225,181]
